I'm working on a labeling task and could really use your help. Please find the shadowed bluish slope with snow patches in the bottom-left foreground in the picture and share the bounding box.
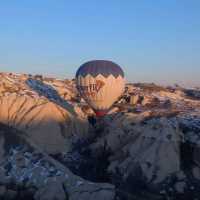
[0,124,115,200]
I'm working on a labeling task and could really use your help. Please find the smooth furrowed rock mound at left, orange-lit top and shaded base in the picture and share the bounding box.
[0,94,88,154]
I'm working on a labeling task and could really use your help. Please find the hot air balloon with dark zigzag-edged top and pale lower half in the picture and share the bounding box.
[76,60,125,116]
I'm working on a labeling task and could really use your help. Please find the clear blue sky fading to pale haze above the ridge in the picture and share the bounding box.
[0,0,200,85]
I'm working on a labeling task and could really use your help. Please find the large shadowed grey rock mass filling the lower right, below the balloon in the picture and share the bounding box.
[83,110,200,198]
